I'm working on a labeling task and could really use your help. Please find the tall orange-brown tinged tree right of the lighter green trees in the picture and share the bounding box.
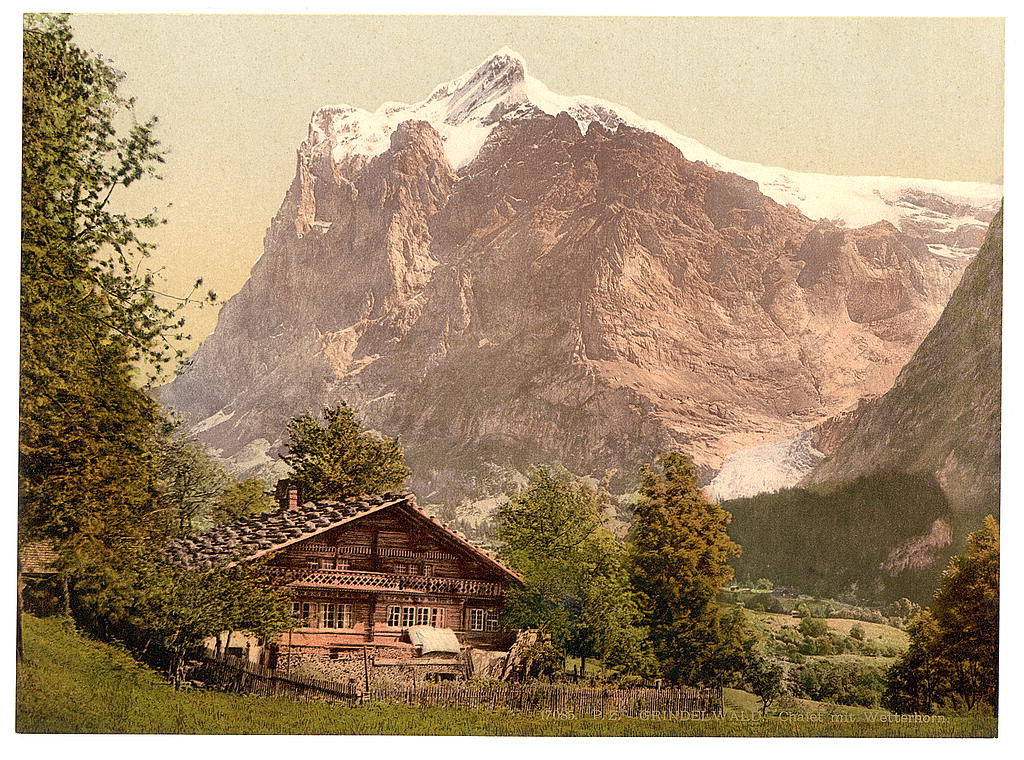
[632,452,741,684]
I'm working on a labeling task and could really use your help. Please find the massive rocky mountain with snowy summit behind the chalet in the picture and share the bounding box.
[161,52,997,503]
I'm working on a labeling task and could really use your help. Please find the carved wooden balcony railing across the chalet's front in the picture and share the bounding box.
[267,566,502,597]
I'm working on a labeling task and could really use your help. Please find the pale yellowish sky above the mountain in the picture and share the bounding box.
[73,15,1005,350]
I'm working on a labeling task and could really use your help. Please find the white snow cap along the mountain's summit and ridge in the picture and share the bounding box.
[302,47,1002,239]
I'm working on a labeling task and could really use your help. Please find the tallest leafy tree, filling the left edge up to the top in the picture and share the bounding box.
[18,13,211,635]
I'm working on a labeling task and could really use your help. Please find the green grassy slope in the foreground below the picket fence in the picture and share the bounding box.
[16,617,996,736]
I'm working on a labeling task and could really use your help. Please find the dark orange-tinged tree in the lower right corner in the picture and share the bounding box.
[886,515,999,712]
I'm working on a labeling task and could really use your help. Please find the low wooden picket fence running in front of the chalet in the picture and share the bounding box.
[193,649,724,718]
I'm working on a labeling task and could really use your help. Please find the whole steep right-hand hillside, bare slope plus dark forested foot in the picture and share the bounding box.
[729,212,1002,603]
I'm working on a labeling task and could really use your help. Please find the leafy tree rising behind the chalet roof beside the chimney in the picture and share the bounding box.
[282,404,409,501]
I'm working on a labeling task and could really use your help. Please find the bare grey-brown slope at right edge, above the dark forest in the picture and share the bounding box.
[805,211,1002,518]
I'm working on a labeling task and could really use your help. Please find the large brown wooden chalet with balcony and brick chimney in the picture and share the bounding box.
[169,481,521,663]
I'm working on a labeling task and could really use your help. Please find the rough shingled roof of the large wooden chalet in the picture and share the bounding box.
[166,493,522,581]
